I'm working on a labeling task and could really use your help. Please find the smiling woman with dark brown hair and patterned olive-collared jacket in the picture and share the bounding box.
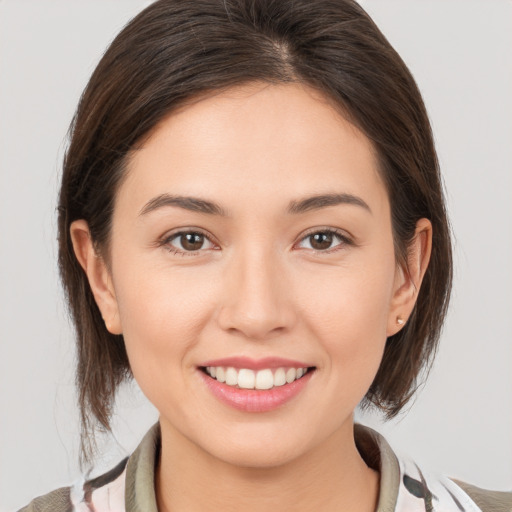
[17,1,510,511]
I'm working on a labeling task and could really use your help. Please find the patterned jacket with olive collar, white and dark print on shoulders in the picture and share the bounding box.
[19,424,512,512]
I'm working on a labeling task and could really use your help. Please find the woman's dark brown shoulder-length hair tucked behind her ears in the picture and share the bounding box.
[59,0,452,460]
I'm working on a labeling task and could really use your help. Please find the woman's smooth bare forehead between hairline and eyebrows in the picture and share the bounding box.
[120,83,385,216]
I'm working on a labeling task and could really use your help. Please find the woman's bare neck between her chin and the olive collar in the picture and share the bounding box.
[156,422,379,512]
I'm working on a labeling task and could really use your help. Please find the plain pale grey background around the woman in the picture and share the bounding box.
[0,0,512,511]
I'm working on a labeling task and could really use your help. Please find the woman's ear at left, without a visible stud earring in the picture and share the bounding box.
[70,220,123,334]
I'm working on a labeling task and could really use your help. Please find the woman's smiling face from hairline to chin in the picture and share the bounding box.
[85,84,412,467]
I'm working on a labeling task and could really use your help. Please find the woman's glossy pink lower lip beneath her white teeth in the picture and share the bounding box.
[199,370,314,412]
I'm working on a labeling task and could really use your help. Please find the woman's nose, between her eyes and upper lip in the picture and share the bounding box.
[218,249,295,340]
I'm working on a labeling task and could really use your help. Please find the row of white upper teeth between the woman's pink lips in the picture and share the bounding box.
[200,366,315,390]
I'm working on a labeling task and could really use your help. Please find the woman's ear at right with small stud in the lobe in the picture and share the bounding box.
[387,219,432,336]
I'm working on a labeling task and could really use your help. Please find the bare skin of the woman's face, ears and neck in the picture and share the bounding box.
[71,83,432,511]
